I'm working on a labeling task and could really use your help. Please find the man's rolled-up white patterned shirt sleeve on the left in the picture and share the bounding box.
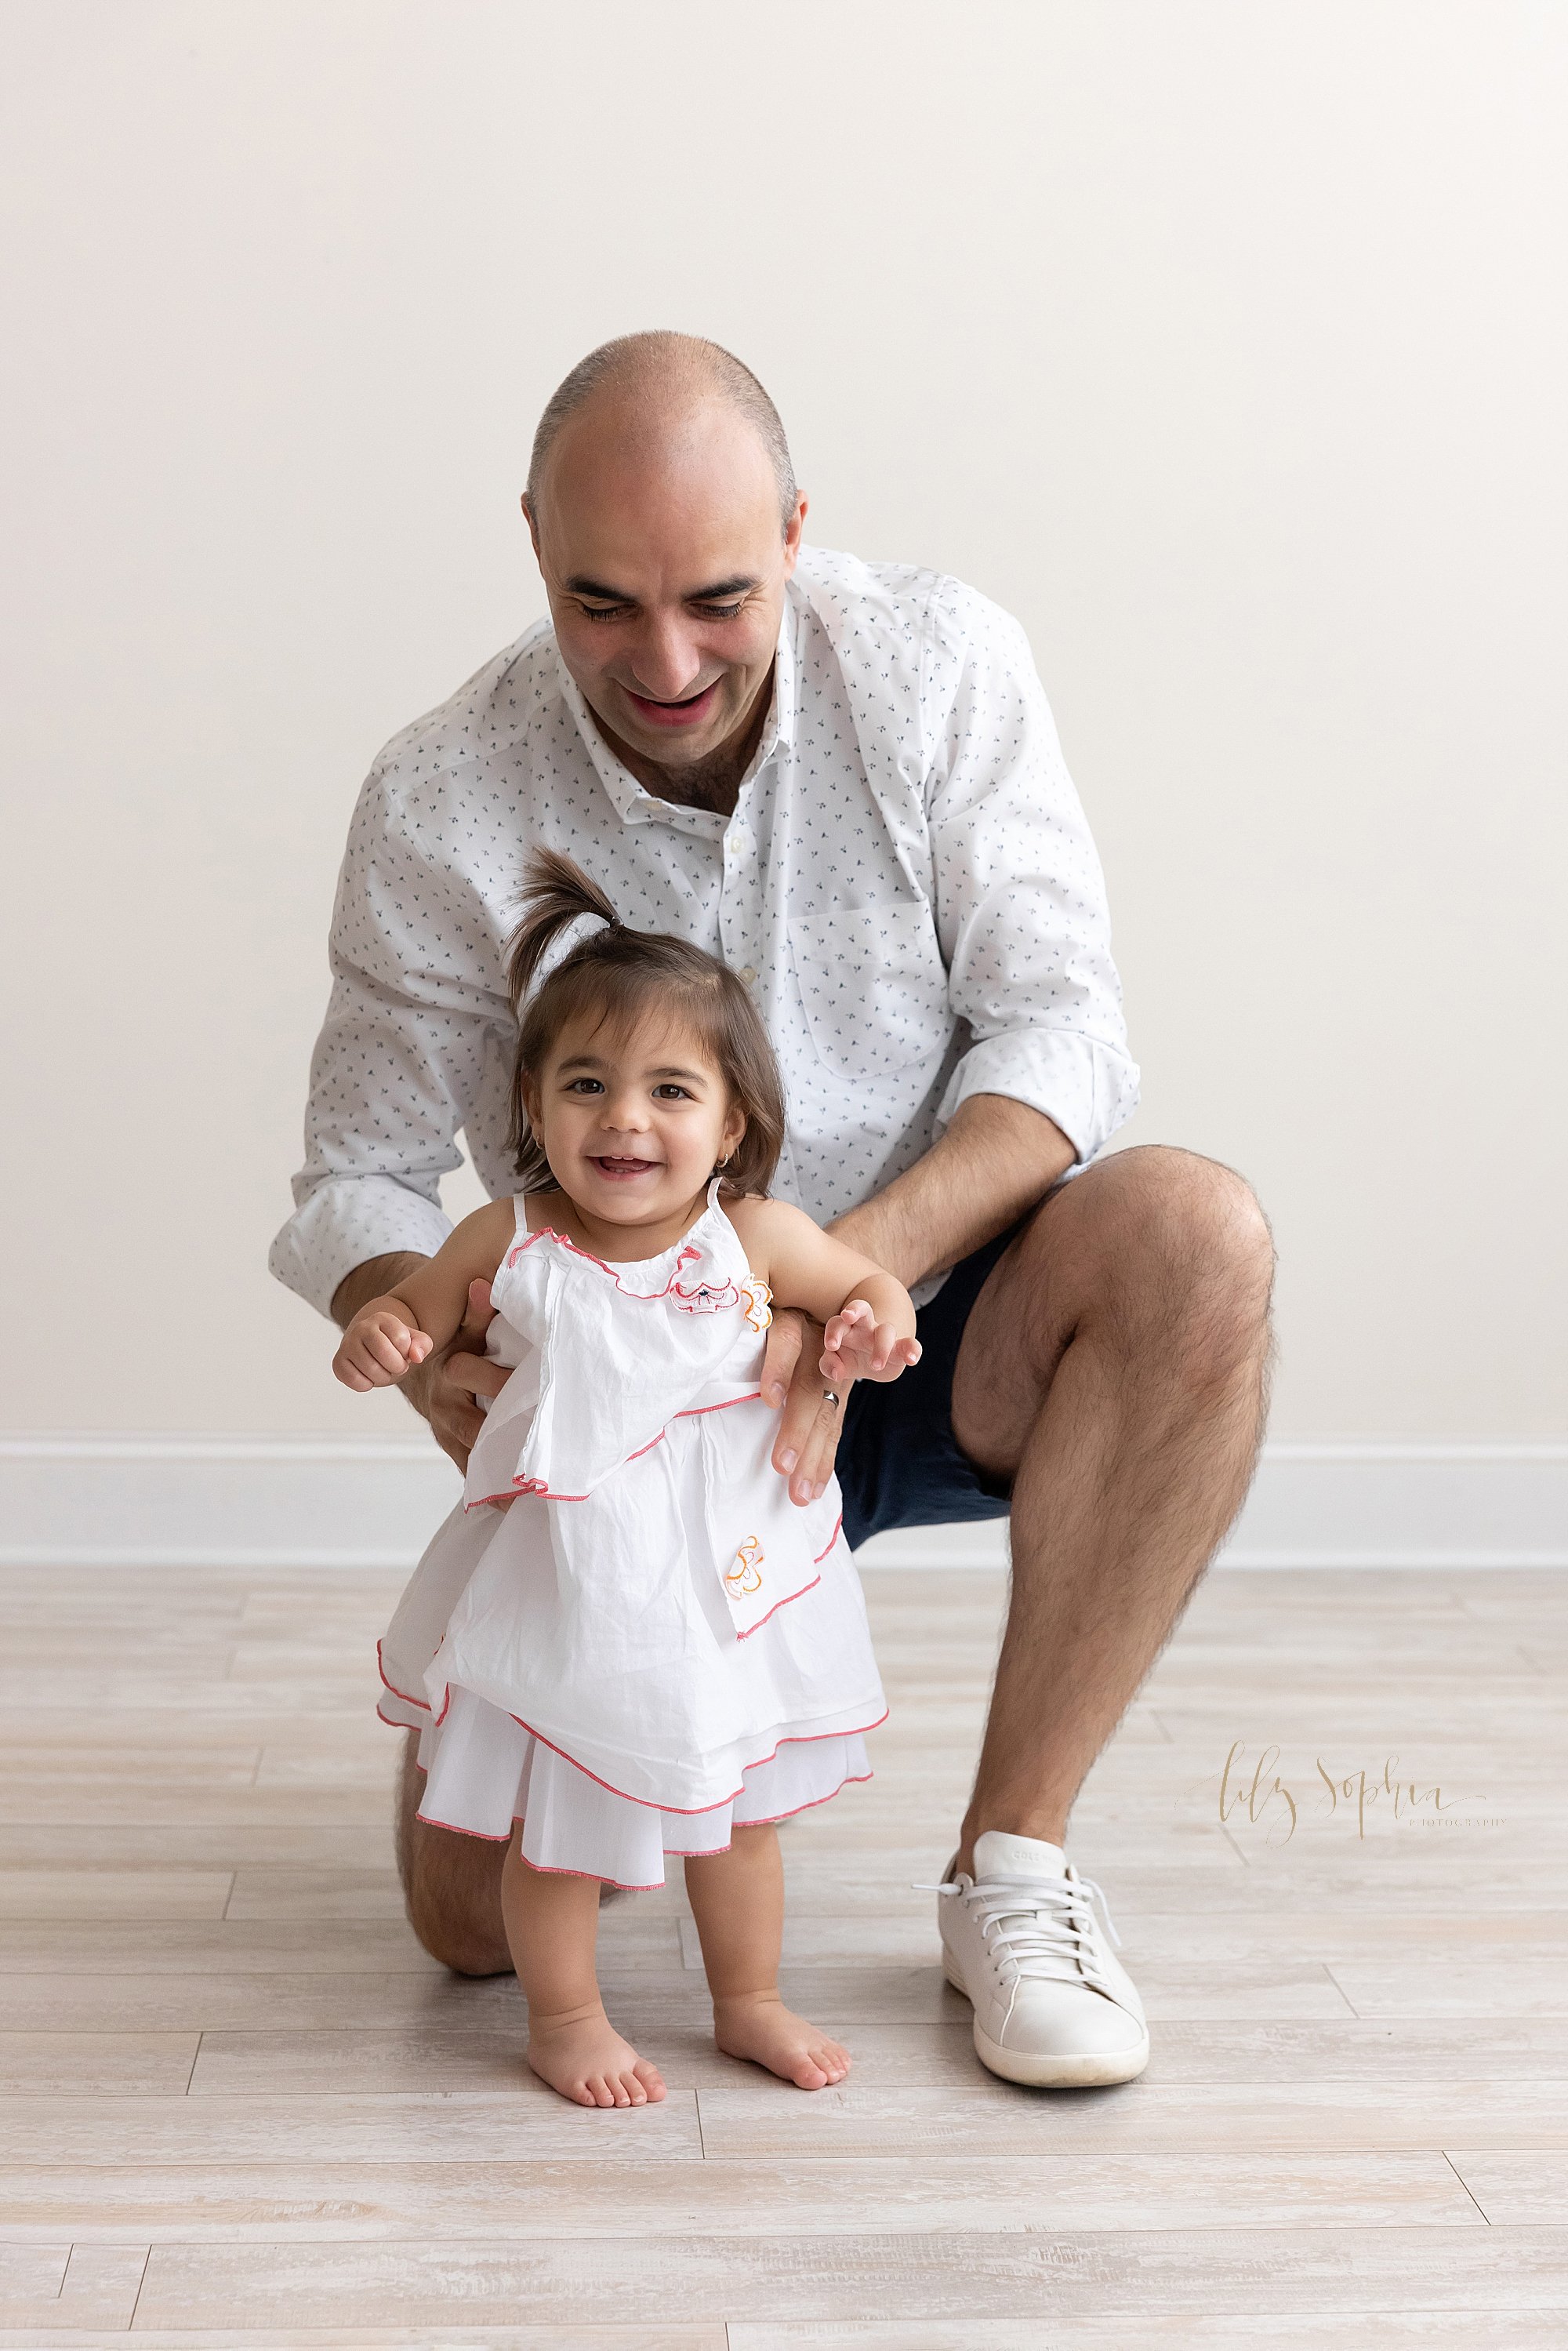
[268,769,510,1314]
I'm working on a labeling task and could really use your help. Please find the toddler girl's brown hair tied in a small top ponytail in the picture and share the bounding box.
[506,848,785,1194]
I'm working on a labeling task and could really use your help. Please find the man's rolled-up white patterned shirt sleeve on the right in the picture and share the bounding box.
[921,583,1138,1164]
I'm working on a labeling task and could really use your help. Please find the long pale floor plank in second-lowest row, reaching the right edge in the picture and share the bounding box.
[125,2229,1568,2327]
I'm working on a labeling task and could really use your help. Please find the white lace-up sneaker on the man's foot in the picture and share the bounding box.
[935,1829,1149,2090]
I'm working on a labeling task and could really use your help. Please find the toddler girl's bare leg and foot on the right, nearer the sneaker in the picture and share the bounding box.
[687,1826,848,2090]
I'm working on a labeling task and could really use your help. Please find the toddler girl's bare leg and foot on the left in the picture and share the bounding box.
[501,1829,666,2106]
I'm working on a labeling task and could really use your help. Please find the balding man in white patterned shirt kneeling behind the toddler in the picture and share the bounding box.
[273,334,1272,2085]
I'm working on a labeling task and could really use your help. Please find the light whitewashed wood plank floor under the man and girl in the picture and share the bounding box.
[0,1571,1568,2351]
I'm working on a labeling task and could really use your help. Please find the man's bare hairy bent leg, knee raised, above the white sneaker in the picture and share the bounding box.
[952,1147,1274,1869]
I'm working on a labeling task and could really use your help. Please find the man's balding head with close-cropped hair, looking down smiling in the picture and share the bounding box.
[522,334,806,769]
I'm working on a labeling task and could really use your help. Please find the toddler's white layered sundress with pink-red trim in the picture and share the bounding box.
[379,1178,886,1888]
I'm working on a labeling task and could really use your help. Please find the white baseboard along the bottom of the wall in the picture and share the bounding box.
[0,1434,1568,1568]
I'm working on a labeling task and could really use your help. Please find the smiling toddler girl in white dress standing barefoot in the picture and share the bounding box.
[334,853,919,2106]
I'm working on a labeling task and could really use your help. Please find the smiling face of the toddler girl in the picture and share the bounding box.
[524,1013,746,1225]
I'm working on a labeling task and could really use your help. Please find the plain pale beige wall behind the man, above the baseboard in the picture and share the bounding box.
[0,0,1568,1437]
